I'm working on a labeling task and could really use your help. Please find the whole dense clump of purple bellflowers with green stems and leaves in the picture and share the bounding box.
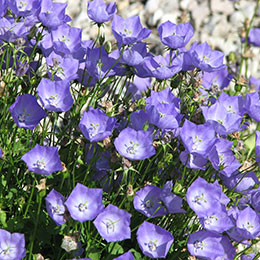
[0,0,260,260]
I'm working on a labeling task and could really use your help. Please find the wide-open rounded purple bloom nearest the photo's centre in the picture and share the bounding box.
[114,127,156,160]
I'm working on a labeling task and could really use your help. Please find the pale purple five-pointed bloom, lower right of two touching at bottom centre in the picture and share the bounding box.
[93,204,131,242]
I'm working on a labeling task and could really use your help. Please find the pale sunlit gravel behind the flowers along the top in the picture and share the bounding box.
[55,0,260,78]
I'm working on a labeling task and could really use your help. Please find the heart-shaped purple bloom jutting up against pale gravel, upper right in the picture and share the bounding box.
[158,21,194,49]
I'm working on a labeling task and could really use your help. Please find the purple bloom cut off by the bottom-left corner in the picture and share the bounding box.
[0,229,26,260]
